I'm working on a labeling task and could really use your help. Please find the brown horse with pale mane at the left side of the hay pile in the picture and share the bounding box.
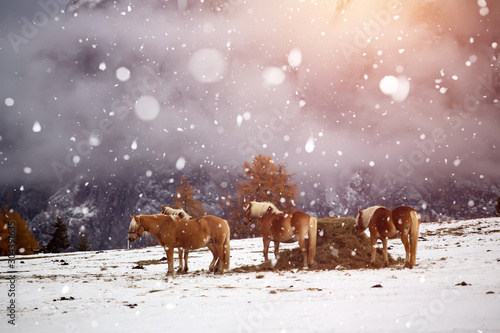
[245,201,318,267]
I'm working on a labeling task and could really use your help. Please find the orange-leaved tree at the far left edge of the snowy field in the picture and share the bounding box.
[0,206,40,256]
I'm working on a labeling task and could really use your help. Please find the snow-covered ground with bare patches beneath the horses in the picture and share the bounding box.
[0,218,500,332]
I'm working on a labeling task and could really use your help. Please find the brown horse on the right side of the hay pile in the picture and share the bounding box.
[356,206,420,268]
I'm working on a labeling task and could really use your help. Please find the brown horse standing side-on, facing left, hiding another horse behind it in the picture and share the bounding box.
[128,214,230,277]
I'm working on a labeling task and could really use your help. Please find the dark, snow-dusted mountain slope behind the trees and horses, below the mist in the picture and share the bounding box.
[0,169,500,250]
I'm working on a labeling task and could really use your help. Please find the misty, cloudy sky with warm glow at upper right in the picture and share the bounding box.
[0,0,500,192]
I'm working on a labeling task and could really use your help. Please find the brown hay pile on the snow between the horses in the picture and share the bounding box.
[236,217,396,272]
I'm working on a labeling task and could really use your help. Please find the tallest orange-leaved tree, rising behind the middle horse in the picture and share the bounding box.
[219,155,297,238]
